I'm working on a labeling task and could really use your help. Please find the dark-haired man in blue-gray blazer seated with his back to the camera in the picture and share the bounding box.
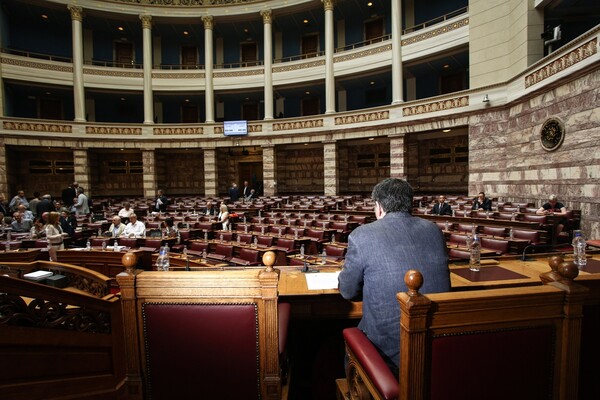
[339,178,450,373]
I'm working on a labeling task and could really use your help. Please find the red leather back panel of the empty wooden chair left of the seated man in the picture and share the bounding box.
[142,303,260,399]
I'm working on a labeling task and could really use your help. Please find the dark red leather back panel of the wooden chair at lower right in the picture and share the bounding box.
[429,326,557,400]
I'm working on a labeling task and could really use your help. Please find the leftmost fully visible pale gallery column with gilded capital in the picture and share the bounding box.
[67,5,85,122]
